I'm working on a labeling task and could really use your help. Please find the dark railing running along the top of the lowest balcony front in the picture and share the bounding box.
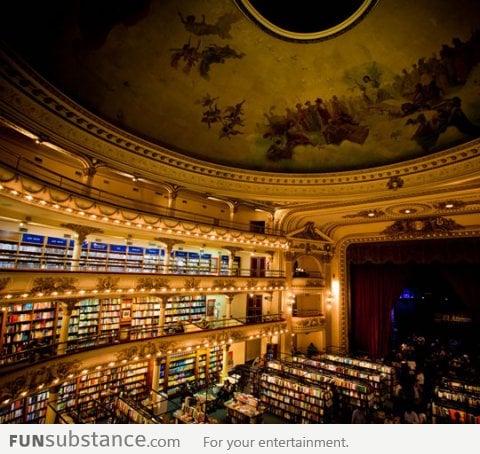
[0,314,284,374]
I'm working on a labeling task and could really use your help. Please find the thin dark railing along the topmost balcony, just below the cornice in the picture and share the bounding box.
[2,154,284,236]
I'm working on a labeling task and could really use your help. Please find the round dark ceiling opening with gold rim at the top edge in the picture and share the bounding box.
[234,0,378,42]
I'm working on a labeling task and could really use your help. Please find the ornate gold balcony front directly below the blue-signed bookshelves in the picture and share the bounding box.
[0,265,285,306]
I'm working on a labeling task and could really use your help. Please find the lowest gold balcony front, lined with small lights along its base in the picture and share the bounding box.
[0,315,287,401]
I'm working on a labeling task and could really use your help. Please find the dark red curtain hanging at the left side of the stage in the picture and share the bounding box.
[350,263,408,359]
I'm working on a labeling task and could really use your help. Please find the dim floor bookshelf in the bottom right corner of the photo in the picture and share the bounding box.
[432,379,480,424]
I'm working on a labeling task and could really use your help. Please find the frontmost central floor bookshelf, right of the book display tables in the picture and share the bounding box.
[260,373,333,424]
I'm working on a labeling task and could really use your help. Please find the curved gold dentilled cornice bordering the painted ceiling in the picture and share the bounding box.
[0,50,480,200]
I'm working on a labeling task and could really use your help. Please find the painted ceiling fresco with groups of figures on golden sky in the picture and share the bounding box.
[0,0,480,173]
